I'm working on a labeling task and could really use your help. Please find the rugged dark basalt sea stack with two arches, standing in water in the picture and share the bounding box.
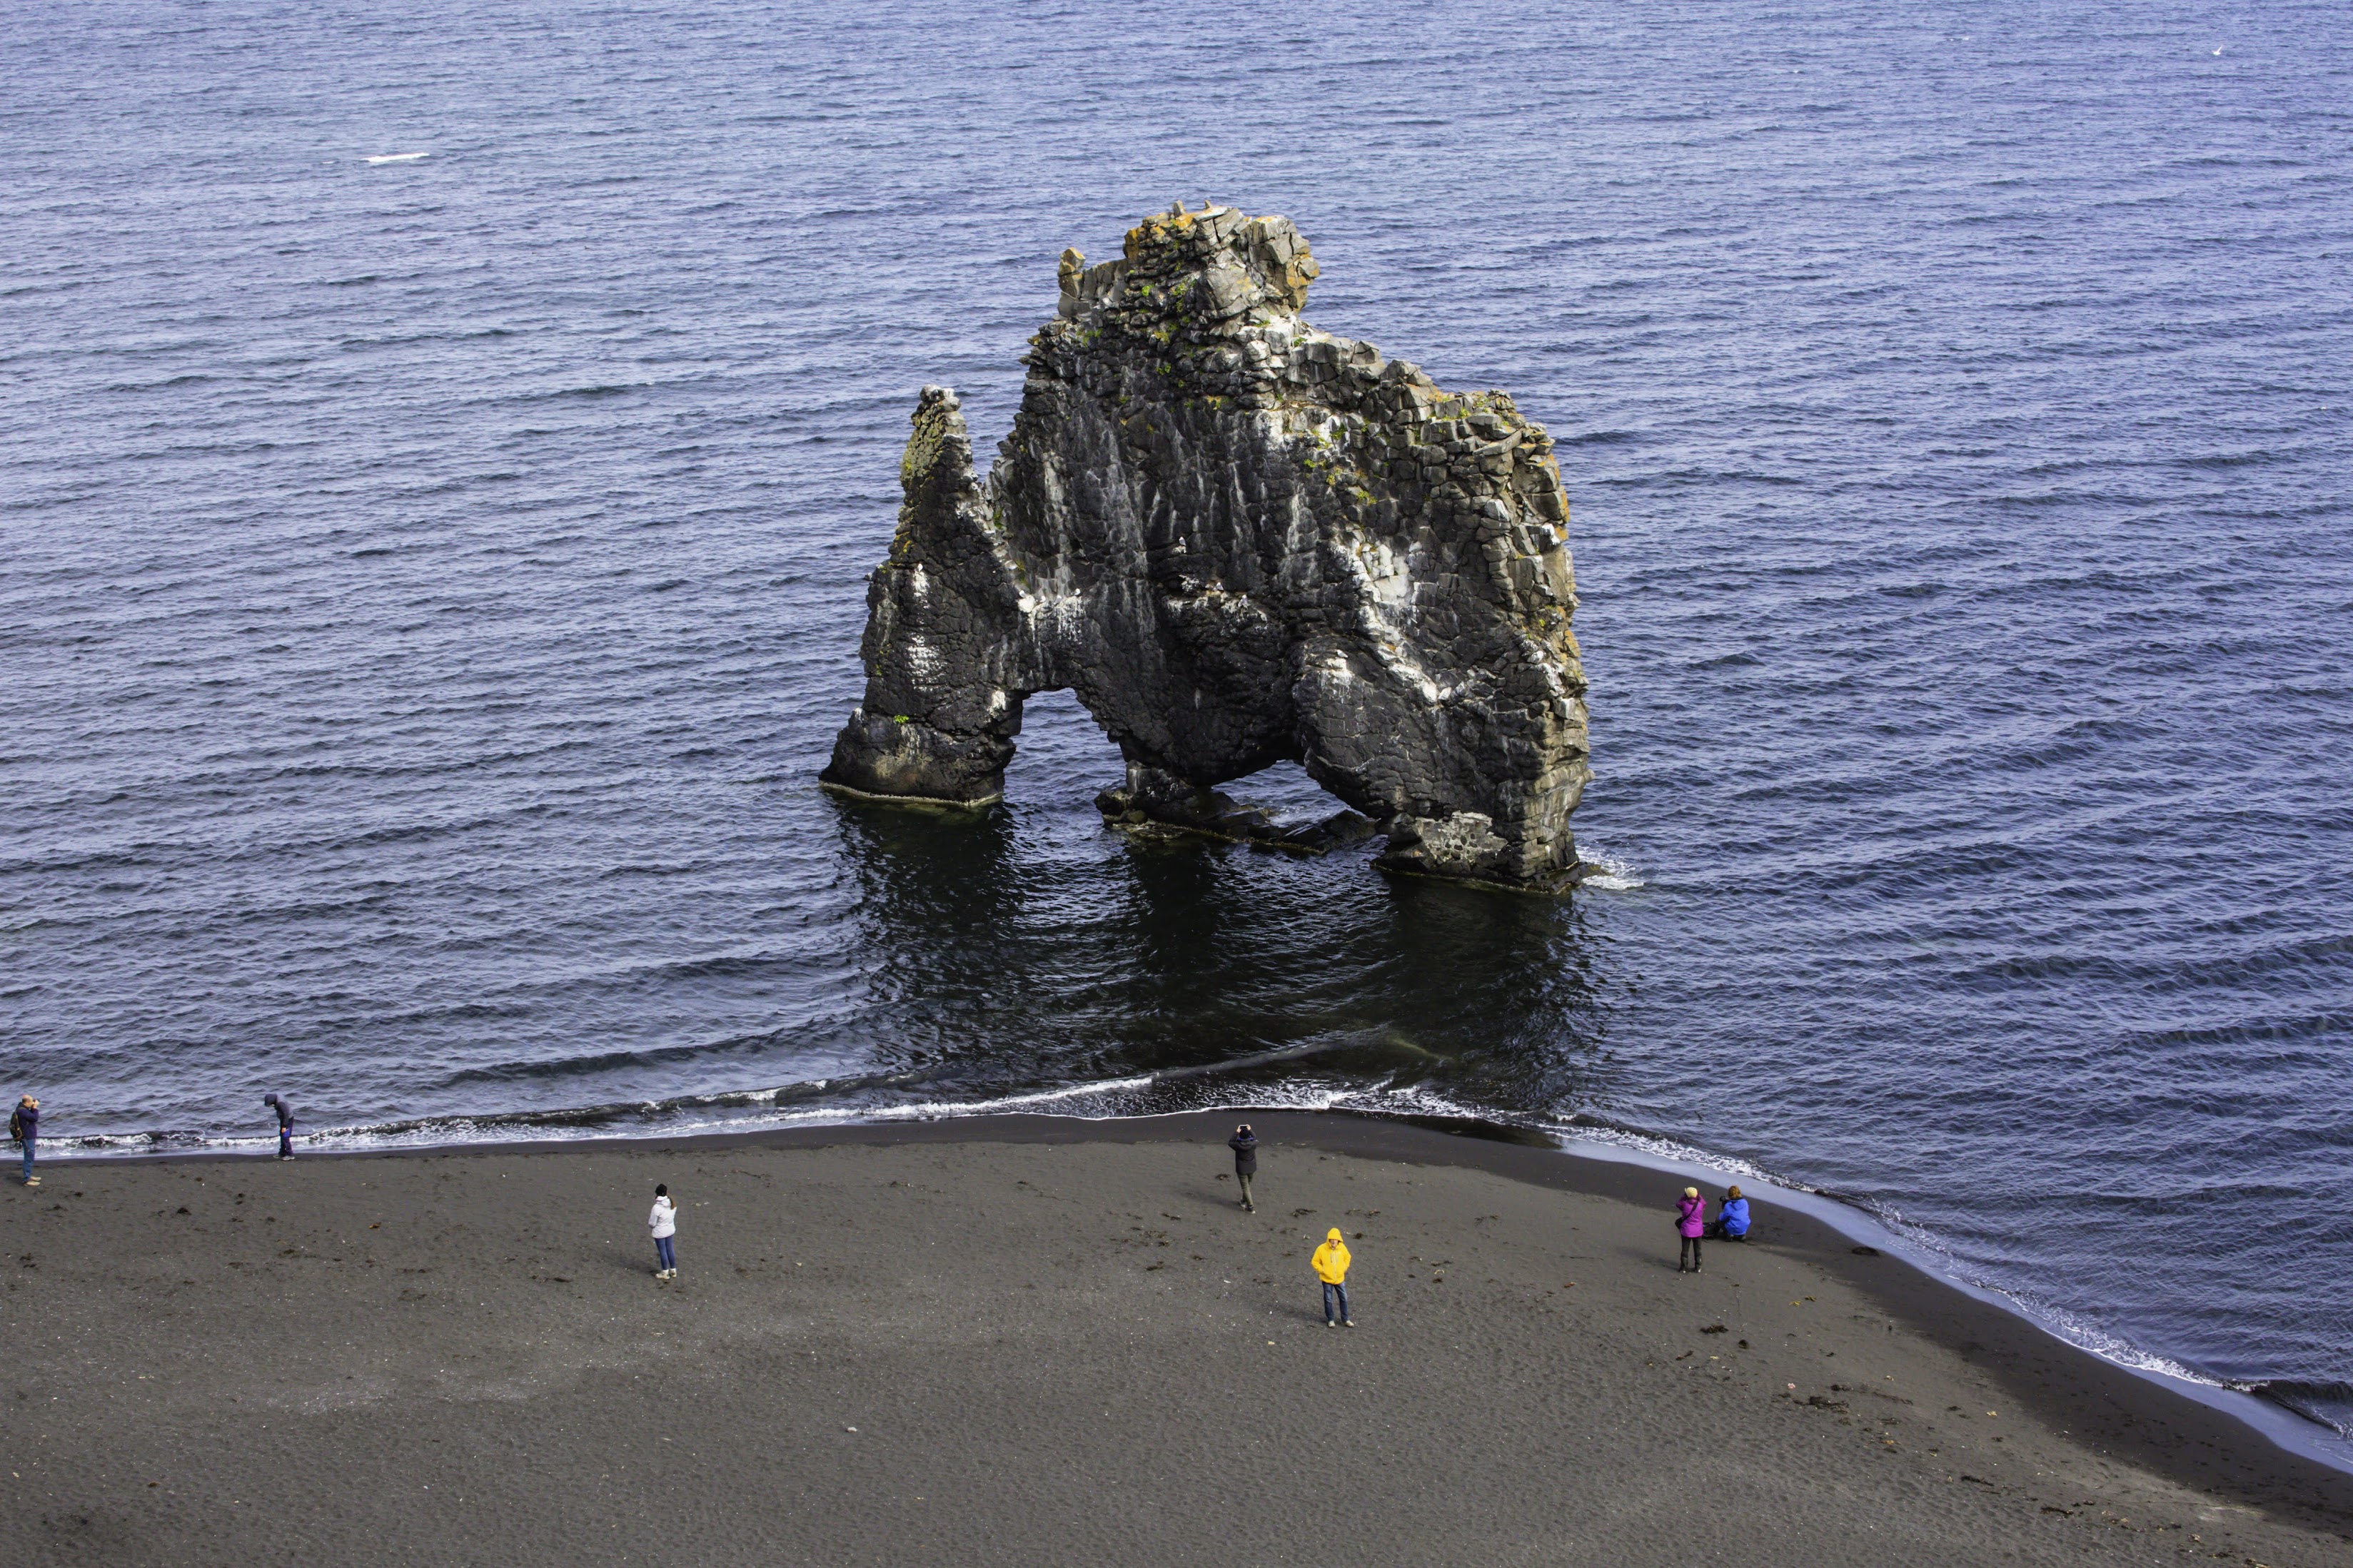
[824,207,1591,889]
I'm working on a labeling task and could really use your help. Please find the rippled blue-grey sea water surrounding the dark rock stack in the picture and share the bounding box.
[0,0,2353,1425]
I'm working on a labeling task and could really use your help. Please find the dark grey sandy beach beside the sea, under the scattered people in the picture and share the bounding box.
[0,1114,2353,1568]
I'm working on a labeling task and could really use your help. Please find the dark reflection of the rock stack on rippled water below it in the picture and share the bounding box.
[837,738,1605,1105]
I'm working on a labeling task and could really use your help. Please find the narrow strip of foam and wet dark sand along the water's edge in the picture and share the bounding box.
[42,1105,2353,1519]
